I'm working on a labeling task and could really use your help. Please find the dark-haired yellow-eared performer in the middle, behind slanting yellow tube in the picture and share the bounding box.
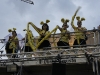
[31,20,51,50]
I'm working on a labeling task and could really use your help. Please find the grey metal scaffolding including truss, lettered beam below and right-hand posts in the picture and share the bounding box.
[0,29,100,75]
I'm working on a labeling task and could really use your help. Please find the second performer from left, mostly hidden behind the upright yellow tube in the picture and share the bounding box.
[22,29,33,57]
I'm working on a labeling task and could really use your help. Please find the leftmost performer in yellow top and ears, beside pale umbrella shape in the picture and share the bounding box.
[5,28,20,58]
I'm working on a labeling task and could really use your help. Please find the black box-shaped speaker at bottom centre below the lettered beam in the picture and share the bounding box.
[52,63,66,75]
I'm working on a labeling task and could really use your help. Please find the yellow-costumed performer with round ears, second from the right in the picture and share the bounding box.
[57,18,70,49]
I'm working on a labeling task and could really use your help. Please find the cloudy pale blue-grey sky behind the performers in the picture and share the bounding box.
[0,0,100,56]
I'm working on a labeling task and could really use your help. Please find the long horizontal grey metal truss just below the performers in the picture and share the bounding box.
[0,46,100,63]
